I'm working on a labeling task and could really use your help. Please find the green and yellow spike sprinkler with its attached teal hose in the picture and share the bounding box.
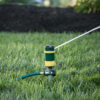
[14,45,56,81]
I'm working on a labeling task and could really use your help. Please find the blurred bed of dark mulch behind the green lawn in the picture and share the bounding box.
[0,5,100,32]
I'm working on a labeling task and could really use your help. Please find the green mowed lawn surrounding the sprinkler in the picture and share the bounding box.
[0,32,100,100]
